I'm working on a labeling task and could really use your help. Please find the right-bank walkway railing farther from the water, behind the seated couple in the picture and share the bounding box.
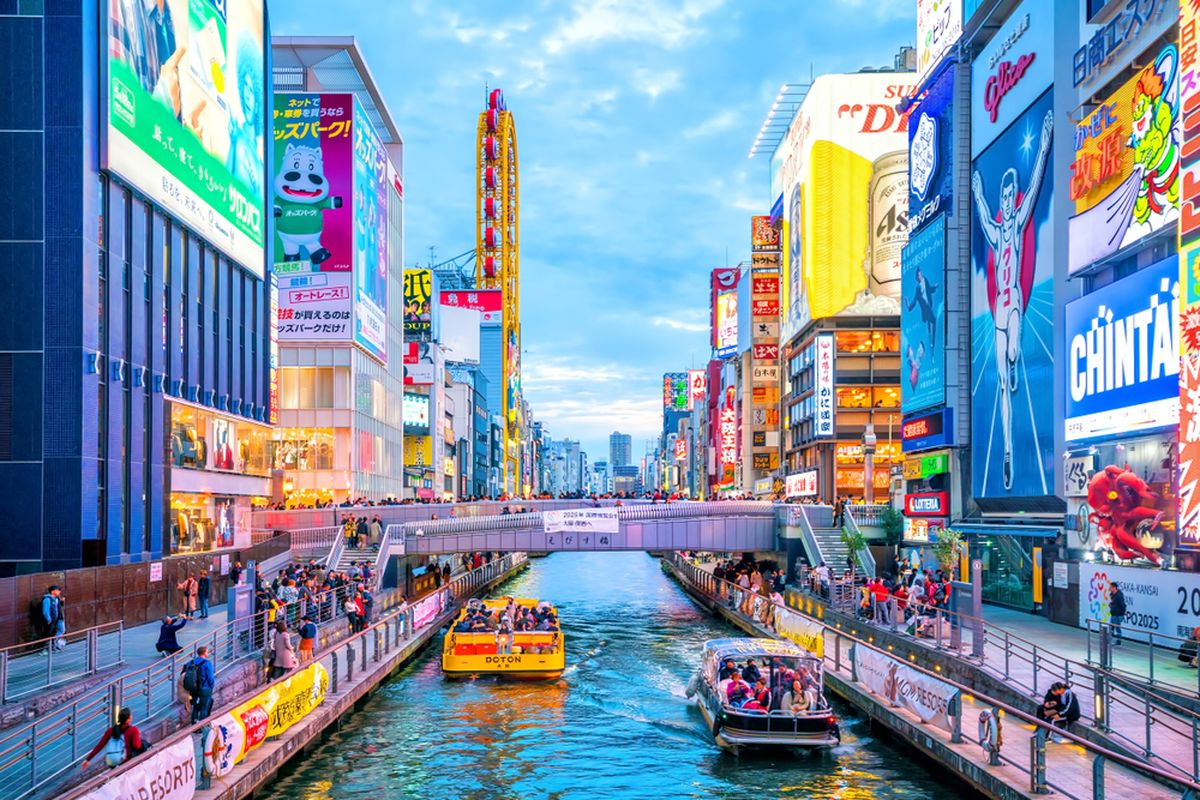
[792,568,1200,780]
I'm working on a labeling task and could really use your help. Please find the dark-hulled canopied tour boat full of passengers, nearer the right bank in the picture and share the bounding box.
[688,638,841,753]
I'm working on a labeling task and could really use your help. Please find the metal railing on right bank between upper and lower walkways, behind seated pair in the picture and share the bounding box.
[796,568,1200,781]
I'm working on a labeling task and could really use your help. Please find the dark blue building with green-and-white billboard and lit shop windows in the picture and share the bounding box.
[0,0,274,575]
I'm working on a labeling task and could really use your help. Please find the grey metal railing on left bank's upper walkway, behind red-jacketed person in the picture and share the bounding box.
[0,587,400,798]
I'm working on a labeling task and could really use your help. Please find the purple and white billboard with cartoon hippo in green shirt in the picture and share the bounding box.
[272,94,355,342]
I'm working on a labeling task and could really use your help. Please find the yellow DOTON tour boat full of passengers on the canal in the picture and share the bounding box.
[442,597,566,680]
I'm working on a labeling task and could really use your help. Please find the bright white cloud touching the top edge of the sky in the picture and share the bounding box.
[542,0,722,54]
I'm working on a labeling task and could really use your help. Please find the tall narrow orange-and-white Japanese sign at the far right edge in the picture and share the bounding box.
[1178,1,1200,541]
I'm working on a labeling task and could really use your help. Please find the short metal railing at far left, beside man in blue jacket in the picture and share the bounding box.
[0,621,125,703]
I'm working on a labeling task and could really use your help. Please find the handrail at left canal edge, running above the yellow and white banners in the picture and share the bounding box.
[62,553,527,799]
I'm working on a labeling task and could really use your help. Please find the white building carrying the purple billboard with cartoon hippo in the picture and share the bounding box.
[268,36,405,503]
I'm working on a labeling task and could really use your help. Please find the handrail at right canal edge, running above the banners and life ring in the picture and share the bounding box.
[670,553,1200,796]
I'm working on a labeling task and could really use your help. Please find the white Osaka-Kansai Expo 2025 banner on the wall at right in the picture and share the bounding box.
[1079,561,1200,642]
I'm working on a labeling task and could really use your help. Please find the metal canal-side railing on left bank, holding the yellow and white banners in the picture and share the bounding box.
[57,553,527,800]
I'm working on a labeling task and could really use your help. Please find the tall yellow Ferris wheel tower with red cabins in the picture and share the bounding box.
[475,89,520,497]
